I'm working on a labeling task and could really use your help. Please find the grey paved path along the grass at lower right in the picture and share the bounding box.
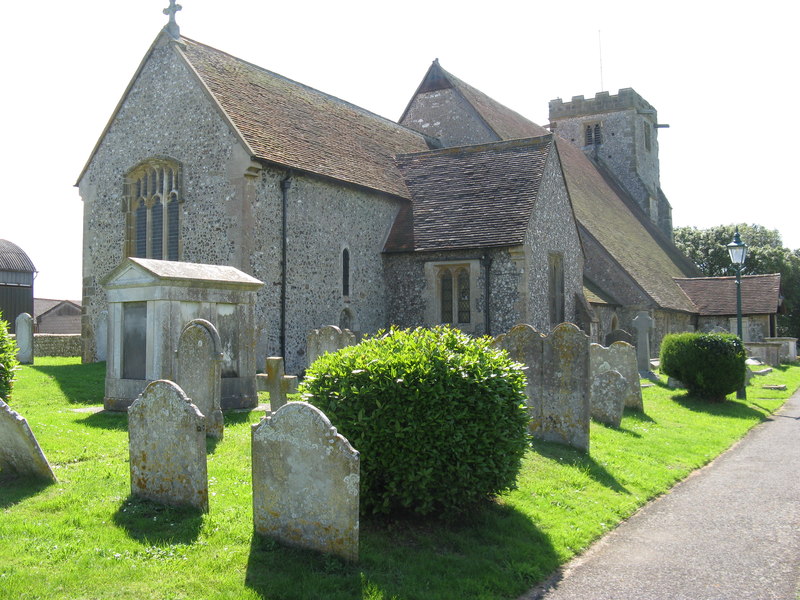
[523,391,800,600]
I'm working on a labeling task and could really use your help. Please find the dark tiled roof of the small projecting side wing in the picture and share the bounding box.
[386,135,553,252]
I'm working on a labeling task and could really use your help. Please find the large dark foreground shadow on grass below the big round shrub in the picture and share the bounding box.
[245,503,559,600]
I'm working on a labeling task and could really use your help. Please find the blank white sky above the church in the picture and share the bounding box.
[0,0,800,299]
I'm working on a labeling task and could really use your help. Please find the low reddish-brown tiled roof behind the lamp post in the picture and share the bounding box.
[675,273,781,316]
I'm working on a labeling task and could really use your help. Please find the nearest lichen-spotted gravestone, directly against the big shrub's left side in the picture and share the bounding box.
[252,402,360,561]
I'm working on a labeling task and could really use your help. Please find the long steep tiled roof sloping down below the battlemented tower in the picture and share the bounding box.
[556,137,695,312]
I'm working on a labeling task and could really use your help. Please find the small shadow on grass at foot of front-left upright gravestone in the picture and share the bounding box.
[113,495,203,546]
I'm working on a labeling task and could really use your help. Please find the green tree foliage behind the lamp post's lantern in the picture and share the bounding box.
[675,223,800,337]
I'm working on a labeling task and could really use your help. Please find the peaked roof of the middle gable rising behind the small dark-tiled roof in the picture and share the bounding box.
[398,59,550,140]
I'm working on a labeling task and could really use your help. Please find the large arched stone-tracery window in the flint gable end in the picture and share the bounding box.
[124,159,183,260]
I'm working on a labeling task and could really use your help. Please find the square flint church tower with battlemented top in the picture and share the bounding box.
[550,88,672,239]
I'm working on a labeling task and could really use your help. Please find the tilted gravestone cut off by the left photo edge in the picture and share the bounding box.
[0,400,56,482]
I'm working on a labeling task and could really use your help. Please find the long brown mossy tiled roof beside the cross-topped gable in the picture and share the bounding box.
[181,38,429,198]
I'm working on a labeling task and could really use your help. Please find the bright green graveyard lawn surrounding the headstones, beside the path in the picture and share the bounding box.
[0,358,800,600]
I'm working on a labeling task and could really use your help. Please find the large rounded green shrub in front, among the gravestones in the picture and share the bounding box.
[301,327,527,515]
